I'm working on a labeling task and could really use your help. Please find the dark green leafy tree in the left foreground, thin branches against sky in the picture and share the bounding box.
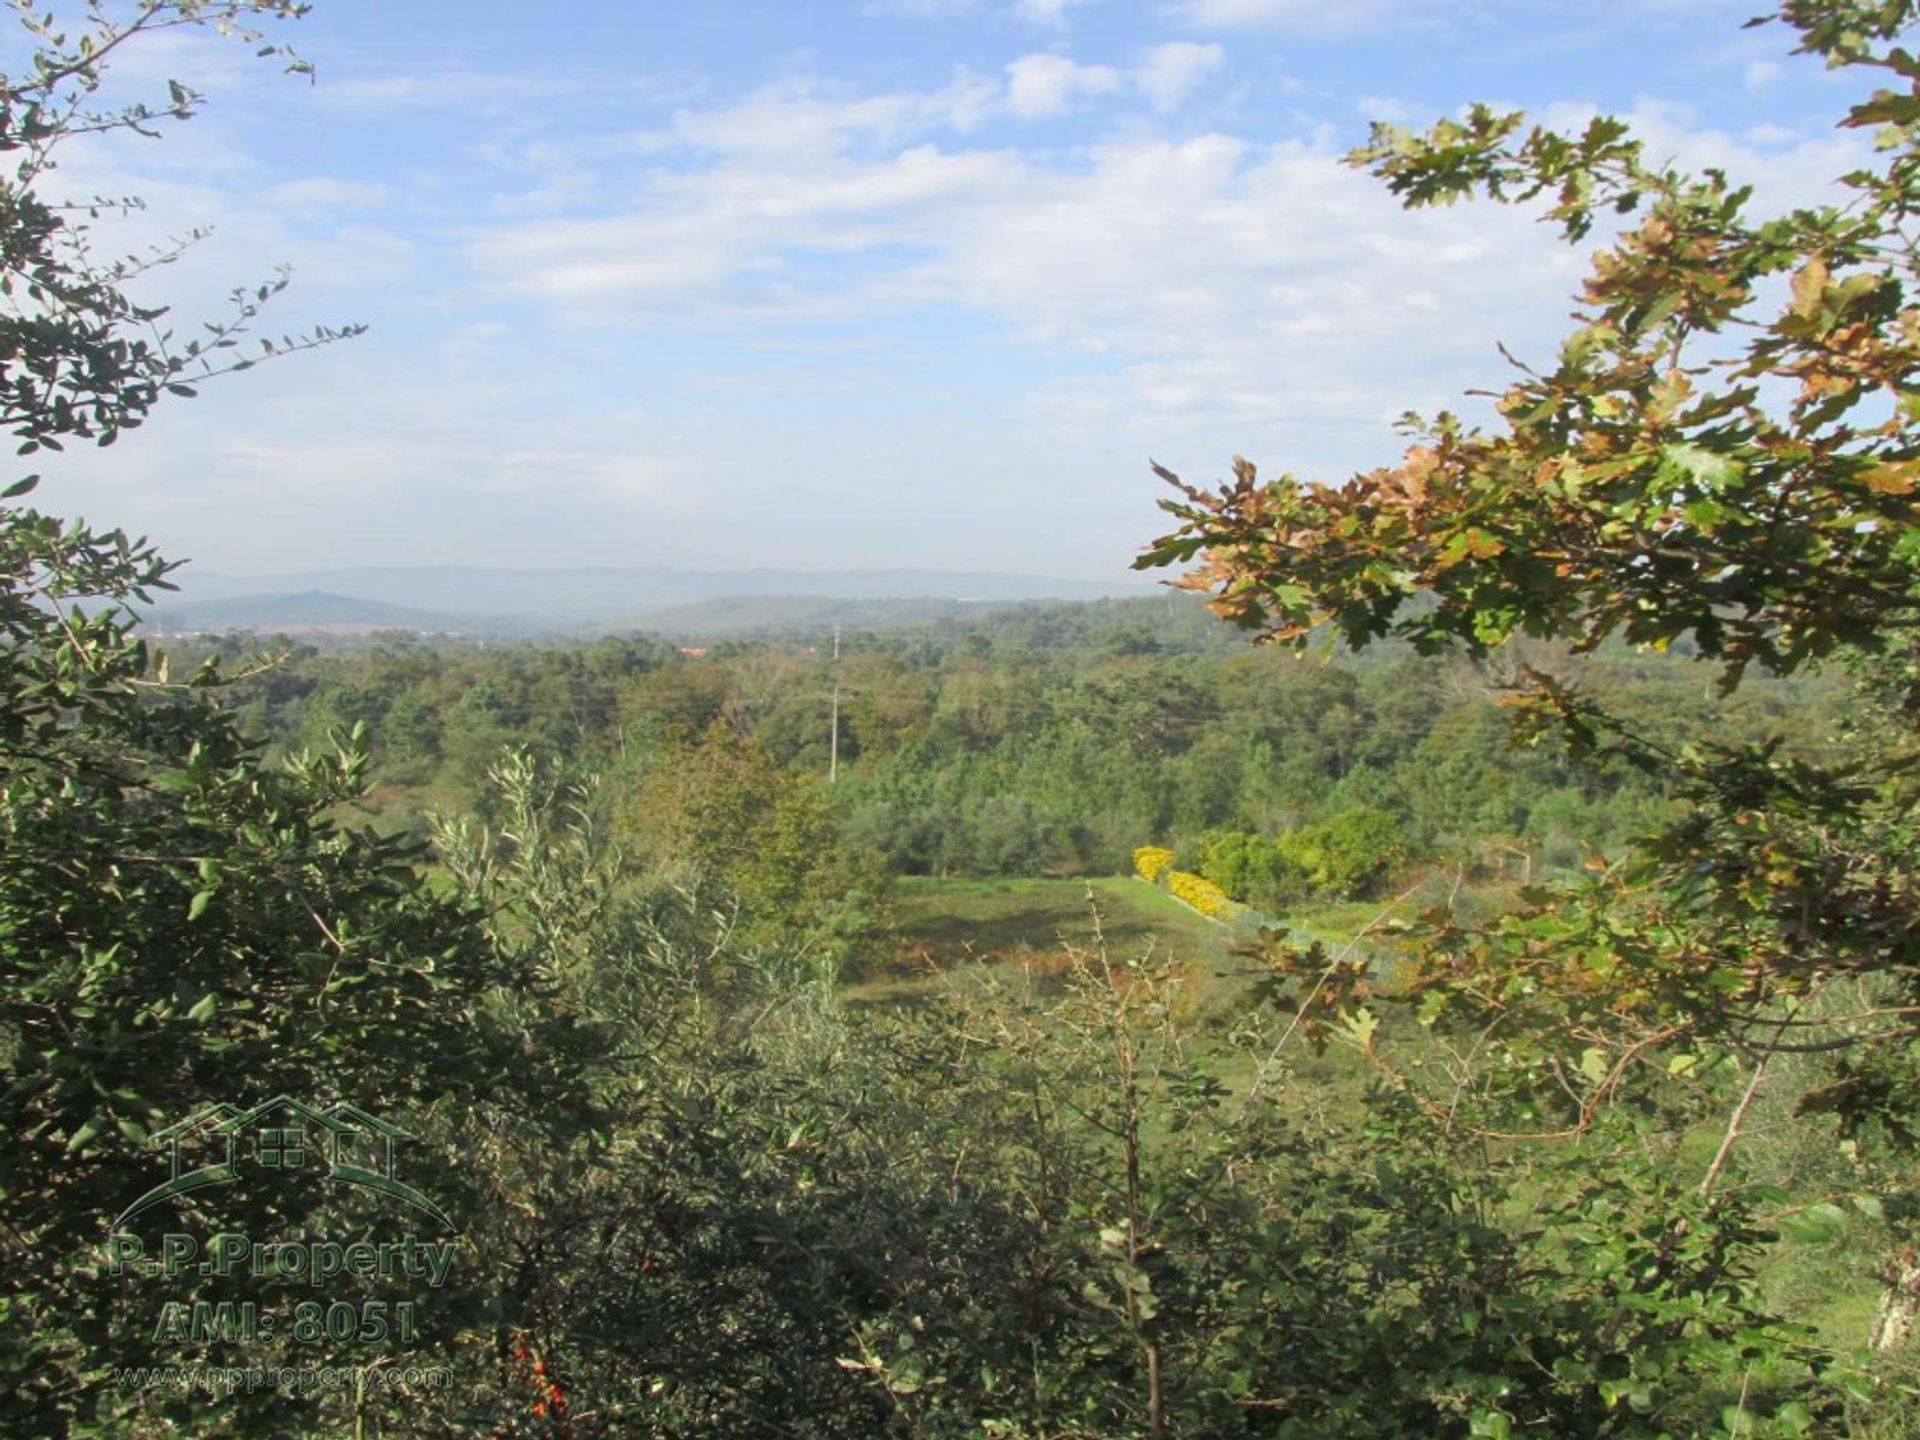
[0,0,578,1434]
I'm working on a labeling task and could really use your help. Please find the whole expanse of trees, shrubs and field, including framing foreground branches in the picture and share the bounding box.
[11,0,1920,1440]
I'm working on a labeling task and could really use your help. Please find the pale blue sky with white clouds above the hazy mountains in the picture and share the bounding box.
[0,0,1866,578]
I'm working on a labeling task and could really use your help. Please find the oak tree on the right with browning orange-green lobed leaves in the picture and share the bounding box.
[1140,0,1920,1367]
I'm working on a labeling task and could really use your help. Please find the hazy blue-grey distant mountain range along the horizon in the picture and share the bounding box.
[146,566,1154,636]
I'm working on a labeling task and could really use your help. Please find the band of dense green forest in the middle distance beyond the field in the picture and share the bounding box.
[186,601,1851,890]
